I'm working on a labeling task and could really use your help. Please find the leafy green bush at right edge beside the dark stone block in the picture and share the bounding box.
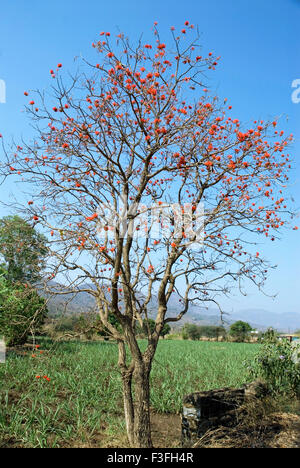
[249,340,300,395]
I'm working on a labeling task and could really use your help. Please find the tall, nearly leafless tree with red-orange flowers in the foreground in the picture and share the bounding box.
[1,22,296,447]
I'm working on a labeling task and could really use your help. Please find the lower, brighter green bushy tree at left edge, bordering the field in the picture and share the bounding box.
[0,268,47,346]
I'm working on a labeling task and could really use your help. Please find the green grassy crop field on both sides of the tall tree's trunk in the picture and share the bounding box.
[0,339,259,447]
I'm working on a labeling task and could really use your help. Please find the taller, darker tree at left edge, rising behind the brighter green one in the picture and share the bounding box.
[0,216,47,284]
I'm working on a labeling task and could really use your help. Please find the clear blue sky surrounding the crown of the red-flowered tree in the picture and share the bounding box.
[0,0,300,312]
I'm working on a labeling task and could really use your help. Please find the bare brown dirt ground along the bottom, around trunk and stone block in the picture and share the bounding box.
[0,413,300,448]
